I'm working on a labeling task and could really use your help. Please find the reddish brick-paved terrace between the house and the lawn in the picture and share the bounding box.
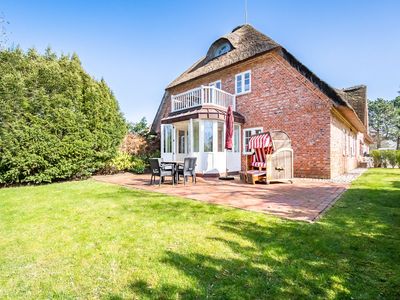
[93,173,348,222]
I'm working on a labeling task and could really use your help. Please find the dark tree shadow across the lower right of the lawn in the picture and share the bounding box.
[129,184,400,299]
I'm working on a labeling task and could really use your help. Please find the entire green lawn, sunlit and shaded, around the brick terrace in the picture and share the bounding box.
[0,169,400,299]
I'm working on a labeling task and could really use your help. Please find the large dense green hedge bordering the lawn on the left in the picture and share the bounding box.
[0,49,126,184]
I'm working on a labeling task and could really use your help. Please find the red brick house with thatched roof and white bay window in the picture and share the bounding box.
[152,25,371,178]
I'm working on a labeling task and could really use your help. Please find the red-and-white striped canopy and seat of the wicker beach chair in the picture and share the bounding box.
[248,132,274,168]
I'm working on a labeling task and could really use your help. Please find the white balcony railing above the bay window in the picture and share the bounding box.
[171,86,236,112]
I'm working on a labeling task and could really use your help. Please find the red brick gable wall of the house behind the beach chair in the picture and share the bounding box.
[163,53,352,178]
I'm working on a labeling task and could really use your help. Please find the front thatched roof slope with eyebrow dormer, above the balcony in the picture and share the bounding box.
[167,25,279,89]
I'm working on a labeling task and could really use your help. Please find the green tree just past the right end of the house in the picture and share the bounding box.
[368,98,396,148]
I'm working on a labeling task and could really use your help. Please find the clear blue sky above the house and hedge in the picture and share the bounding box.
[0,0,400,122]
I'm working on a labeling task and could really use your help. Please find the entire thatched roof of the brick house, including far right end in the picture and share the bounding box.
[153,25,368,138]
